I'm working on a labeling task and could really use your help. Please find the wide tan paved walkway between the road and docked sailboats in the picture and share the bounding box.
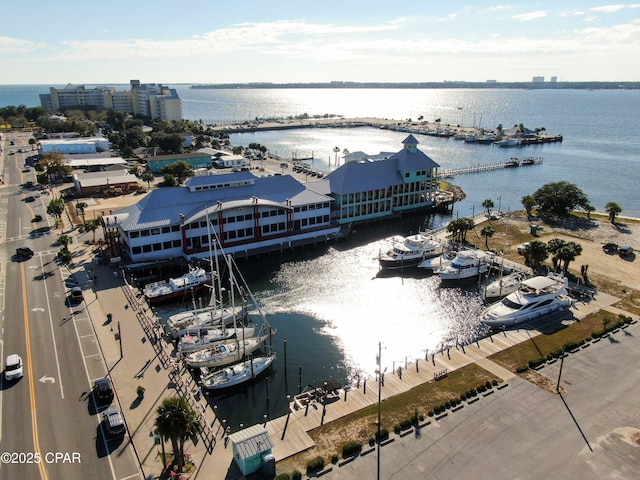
[69,243,242,479]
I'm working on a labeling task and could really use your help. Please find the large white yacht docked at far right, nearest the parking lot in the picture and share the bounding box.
[480,274,573,328]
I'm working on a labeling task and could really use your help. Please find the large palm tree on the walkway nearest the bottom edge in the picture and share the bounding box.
[154,397,202,472]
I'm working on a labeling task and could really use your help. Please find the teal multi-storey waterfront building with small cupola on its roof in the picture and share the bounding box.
[310,135,439,224]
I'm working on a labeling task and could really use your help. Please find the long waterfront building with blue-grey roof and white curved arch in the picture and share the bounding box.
[102,171,340,262]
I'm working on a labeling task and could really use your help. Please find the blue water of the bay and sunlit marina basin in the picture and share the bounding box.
[0,85,640,430]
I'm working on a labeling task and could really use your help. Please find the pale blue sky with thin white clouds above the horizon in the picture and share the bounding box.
[0,0,640,85]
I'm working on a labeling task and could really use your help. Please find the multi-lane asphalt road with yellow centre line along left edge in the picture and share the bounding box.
[0,134,139,479]
